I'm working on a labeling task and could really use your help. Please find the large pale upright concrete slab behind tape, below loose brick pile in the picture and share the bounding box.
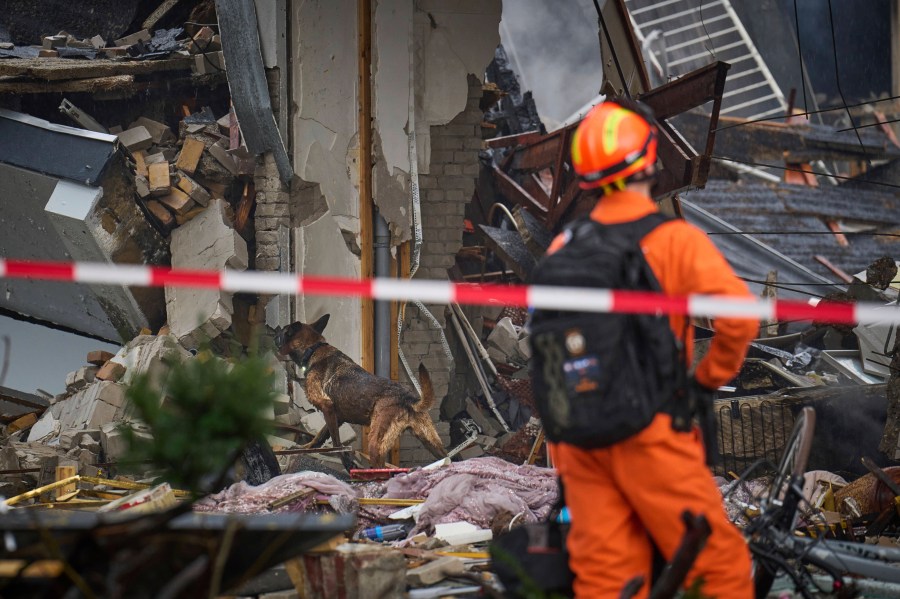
[166,200,248,348]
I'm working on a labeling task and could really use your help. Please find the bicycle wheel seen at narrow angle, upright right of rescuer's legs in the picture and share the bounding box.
[750,407,816,599]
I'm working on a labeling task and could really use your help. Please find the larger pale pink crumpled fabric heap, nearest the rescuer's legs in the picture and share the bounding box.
[385,457,559,535]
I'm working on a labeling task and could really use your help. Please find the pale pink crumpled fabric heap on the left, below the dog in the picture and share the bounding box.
[194,471,358,514]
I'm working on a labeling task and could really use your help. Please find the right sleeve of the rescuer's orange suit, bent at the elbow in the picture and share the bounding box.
[673,223,759,389]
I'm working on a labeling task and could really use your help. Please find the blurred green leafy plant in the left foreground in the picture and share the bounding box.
[121,350,276,493]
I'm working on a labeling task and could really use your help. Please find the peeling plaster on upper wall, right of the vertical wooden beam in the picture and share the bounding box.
[373,0,501,245]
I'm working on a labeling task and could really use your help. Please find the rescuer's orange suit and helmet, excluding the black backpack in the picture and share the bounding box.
[549,102,758,599]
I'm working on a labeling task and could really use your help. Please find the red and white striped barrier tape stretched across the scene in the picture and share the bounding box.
[0,258,900,324]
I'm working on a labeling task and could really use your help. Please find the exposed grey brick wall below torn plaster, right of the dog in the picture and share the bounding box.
[400,75,484,466]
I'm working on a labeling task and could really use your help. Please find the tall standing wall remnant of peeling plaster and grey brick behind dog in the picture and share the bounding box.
[280,0,500,463]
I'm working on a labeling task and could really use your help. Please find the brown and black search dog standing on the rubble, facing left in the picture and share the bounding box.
[275,314,447,470]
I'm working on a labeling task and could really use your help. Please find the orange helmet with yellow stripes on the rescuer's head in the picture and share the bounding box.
[572,102,657,191]
